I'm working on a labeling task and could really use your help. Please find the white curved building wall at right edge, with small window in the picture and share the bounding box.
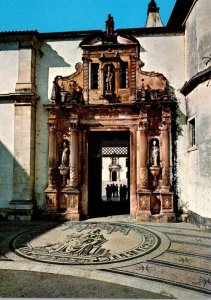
[185,0,211,218]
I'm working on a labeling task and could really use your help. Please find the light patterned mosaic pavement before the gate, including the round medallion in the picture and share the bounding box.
[0,216,211,299]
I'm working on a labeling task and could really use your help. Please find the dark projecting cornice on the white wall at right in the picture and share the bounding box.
[180,66,211,96]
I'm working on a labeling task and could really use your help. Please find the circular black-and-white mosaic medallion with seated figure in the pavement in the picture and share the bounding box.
[11,222,166,264]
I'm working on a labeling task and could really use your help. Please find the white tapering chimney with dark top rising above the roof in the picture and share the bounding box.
[145,0,163,27]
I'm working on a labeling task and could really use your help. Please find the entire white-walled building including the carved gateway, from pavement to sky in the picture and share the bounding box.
[0,0,211,229]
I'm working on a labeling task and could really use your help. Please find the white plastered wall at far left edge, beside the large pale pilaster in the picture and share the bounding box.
[0,42,19,208]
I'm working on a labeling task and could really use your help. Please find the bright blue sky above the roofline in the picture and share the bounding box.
[0,0,176,32]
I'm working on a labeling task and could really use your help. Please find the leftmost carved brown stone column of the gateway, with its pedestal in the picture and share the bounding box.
[44,111,58,215]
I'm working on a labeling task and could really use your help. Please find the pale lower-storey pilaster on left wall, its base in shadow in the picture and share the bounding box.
[9,95,37,220]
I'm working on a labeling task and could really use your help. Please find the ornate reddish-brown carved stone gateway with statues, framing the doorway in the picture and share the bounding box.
[45,15,175,221]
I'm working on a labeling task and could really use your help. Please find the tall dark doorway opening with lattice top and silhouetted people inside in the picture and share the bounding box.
[88,131,130,217]
